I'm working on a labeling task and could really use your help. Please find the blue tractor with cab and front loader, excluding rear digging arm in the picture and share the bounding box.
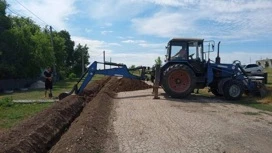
[155,38,266,100]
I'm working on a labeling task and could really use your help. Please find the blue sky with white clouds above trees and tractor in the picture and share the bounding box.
[7,0,272,66]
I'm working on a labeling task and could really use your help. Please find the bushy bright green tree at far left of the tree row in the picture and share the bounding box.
[0,17,55,79]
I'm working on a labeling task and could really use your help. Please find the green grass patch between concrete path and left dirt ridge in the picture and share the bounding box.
[0,98,52,130]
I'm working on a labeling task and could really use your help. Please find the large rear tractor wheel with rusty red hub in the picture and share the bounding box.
[162,64,196,98]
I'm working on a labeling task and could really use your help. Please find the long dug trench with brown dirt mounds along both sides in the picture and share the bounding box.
[0,77,151,153]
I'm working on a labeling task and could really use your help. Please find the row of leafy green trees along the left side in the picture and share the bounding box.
[0,0,89,79]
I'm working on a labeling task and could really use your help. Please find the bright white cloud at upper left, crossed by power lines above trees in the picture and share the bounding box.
[8,0,77,30]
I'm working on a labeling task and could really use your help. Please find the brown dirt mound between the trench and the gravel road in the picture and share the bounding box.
[50,77,150,153]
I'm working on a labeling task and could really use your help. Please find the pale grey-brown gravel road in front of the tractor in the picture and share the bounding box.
[109,89,272,153]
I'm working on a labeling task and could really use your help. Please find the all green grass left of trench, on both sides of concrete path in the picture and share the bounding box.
[0,75,104,131]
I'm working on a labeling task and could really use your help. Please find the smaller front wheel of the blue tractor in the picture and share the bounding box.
[223,80,244,100]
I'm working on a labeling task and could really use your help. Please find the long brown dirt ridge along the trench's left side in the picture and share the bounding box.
[0,78,109,153]
